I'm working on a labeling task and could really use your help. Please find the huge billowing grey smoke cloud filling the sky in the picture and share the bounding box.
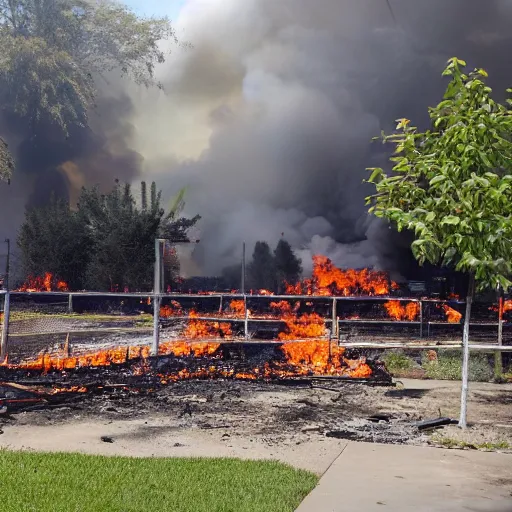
[0,0,512,275]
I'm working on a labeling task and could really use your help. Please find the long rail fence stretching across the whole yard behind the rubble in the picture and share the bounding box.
[0,290,512,361]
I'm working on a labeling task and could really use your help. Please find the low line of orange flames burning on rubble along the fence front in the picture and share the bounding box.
[1,340,372,383]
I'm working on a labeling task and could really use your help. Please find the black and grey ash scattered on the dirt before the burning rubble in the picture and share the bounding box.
[0,380,434,445]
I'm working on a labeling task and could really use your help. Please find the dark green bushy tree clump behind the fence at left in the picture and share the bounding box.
[18,183,199,291]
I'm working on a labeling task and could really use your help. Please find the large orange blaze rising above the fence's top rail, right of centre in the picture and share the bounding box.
[286,256,398,297]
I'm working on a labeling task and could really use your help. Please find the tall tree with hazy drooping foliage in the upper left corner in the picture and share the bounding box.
[0,0,174,178]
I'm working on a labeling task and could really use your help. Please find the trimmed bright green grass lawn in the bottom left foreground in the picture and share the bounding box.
[0,451,318,512]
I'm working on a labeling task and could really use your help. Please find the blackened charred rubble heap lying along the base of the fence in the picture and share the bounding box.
[0,343,391,412]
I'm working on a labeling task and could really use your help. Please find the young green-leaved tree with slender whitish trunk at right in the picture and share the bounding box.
[368,58,512,427]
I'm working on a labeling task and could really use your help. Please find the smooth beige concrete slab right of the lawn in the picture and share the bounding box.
[296,442,512,512]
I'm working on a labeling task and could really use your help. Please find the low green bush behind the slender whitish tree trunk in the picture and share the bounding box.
[422,350,494,382]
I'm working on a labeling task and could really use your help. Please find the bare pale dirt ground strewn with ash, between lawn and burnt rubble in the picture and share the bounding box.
[0,380,512,473]
